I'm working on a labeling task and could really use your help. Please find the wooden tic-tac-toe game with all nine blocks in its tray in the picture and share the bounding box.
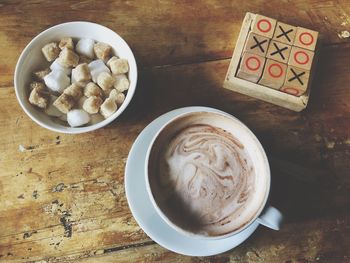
[224,13,318,111]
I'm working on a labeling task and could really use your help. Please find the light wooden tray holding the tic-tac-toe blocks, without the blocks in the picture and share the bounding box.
[223,12,317,112]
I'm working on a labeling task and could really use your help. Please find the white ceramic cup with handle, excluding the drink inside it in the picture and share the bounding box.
[145,111,283,239]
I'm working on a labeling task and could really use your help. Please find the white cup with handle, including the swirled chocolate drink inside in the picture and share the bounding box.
[145,111,282,239]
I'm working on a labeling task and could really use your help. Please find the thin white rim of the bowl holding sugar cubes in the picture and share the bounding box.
[14,21,138,134]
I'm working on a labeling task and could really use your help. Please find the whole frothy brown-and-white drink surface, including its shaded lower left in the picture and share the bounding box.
[150,117,256,236]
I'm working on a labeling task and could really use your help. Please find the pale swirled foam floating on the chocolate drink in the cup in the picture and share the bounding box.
[160,124,255,234]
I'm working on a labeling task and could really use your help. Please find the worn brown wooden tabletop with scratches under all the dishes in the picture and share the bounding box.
[0,0,350,263]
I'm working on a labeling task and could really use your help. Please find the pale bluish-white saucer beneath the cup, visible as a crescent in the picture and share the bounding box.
[125,107,259,256]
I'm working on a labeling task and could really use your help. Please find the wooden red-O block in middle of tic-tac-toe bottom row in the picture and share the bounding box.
[259,59,287,89]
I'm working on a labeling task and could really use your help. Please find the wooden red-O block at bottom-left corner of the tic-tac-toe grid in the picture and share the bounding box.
[237,52,266,83]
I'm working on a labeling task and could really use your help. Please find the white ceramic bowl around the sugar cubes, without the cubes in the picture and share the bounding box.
[14,22,137,134]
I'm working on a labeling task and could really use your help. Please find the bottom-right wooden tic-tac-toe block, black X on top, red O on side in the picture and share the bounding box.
[281,66,310,96]
